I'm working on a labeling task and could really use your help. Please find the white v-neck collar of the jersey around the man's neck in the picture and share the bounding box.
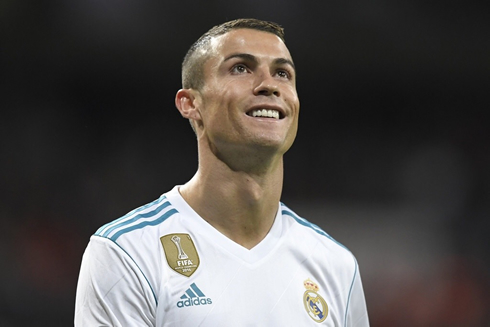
[166,186,283,264]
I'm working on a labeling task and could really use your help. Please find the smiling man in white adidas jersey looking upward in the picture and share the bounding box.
[75,19,369,327]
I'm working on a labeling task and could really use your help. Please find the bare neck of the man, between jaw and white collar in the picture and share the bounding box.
[180,146,283,249]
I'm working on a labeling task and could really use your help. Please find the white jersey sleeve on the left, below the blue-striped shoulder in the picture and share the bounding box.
[75,236,156,327]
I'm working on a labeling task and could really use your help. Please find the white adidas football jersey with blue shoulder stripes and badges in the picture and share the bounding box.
[75,187,369,327]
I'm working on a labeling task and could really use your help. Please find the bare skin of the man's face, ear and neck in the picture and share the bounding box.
[175,29,300,249]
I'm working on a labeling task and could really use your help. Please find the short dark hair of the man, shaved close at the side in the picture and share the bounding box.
[182,18,286,90]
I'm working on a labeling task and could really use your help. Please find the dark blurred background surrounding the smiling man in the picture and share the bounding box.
[0,0,490,327]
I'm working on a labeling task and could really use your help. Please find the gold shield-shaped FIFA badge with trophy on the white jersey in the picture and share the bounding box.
[160,234,199,277]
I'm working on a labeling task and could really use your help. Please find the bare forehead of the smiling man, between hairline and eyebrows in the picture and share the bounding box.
[211,28,292,60]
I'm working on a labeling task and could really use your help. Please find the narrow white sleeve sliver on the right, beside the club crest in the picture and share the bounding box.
[345,262,369,327]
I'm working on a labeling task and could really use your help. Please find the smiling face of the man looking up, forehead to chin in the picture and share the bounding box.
[195,29,299,160]
